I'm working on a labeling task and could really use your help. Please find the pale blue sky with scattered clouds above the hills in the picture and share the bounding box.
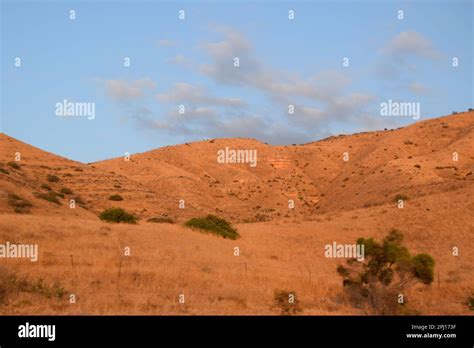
[0,0,474,163]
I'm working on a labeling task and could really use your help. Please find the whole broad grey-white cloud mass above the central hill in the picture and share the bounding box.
[112,27,382,144]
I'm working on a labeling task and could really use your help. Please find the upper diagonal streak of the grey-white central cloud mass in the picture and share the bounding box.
[196,28,374,127]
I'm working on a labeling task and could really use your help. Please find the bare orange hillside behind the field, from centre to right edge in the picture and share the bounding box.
[94,112,474,222]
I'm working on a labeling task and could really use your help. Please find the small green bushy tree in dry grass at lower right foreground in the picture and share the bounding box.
[337,230,435,315]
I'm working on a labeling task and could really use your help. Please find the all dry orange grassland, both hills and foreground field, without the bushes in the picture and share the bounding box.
[0,112,474,315]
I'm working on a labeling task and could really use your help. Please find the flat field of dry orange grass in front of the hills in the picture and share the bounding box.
[0,188,474,315]
